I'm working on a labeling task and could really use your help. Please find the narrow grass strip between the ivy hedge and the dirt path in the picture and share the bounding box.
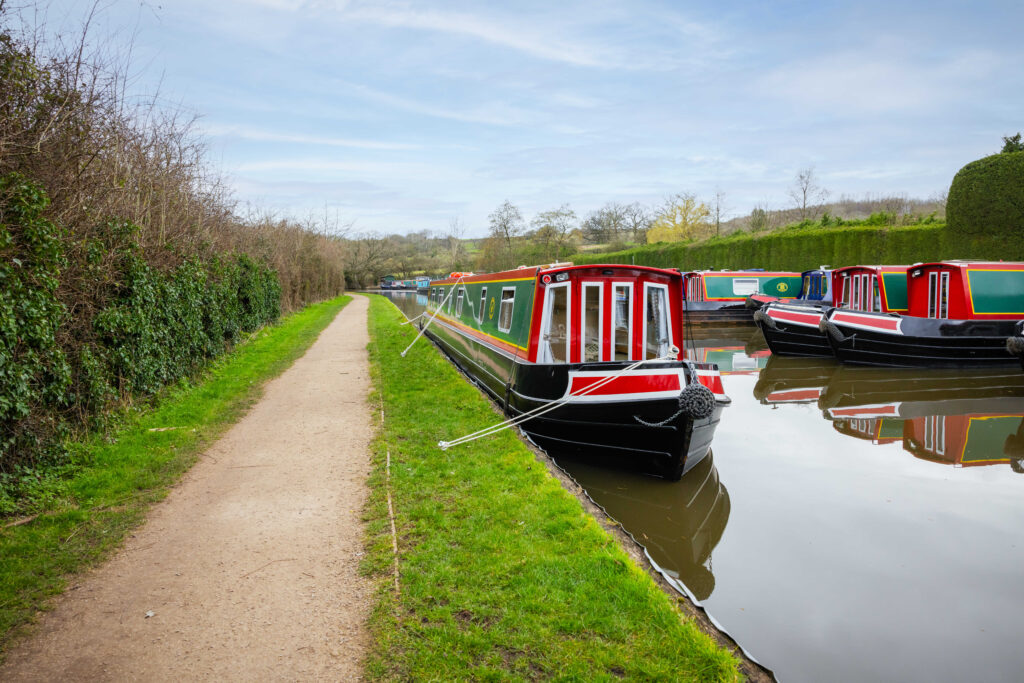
[0,296,351,651]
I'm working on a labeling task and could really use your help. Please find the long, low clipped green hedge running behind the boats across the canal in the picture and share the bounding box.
[569,221,1024,272]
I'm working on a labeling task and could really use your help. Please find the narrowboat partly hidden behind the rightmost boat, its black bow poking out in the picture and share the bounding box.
[754,265,907,356]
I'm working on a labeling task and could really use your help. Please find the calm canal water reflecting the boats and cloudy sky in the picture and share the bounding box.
[380,293,1024,681]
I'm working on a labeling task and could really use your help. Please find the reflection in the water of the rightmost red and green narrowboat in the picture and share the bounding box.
[818,368,1024,472]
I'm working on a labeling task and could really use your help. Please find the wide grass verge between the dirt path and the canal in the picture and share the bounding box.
[364,296,738,681]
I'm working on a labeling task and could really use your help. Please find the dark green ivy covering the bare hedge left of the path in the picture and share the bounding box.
[0,173,281,509]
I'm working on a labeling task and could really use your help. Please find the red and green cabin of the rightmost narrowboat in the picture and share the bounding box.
[907,261,1024,321]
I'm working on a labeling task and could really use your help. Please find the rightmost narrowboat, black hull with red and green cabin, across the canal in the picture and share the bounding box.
[820,261,1024,368]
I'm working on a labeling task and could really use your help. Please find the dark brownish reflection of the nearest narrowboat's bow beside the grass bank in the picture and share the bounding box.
[551,453,730,600]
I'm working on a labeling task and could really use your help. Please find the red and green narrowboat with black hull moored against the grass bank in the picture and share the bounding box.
[420,264,730,480]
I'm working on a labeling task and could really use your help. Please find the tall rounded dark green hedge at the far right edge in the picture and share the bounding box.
[946,152,1024,249]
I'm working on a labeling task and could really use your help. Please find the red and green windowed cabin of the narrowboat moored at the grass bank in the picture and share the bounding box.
[429,265,683,364]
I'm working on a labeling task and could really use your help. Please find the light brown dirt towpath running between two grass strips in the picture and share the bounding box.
[0,297,372,681]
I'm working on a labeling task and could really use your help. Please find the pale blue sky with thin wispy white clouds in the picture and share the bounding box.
[32,0,1024,237]
